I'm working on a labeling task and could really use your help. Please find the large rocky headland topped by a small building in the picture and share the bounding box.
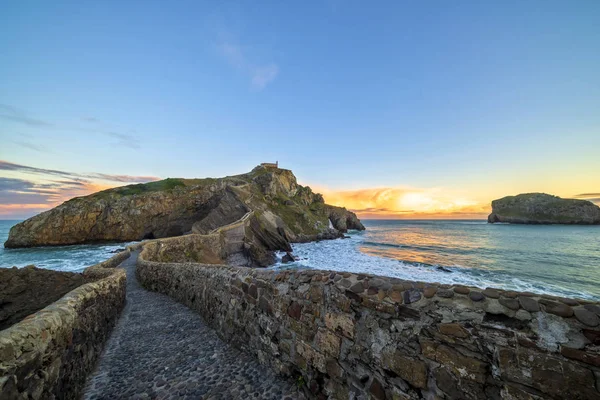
[5,166,364,264]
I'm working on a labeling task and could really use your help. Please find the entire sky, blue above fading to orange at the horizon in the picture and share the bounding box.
[0,0,600,219]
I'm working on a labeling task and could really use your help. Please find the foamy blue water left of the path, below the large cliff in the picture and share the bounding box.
[0,220,134,272]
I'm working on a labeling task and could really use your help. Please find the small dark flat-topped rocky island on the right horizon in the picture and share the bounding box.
[488,193,600,225]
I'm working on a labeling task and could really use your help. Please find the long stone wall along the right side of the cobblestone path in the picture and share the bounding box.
[137,252,600,400]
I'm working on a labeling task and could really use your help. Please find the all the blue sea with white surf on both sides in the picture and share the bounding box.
[0,220,600,300]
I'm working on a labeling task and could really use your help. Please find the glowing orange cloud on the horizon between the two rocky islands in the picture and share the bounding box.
[321,187,490,219]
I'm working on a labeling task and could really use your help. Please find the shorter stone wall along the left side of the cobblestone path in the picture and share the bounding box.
[0,251,129,400]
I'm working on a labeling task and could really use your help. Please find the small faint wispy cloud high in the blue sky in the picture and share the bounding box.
[218,42,279,90]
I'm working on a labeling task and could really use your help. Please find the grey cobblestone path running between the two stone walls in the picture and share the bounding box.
[83,252,304,400]
